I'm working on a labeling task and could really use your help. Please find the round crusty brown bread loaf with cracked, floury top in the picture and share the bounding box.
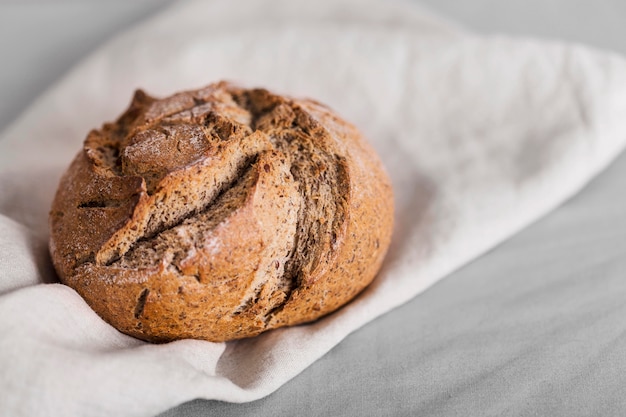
[50,83,393,342]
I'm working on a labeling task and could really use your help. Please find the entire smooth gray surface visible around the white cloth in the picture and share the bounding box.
[0,0,626,417]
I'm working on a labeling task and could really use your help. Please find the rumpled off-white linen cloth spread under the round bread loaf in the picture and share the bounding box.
[0,0,626,416]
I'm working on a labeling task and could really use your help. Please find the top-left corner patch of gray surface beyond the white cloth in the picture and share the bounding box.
[0,0,172,131]
